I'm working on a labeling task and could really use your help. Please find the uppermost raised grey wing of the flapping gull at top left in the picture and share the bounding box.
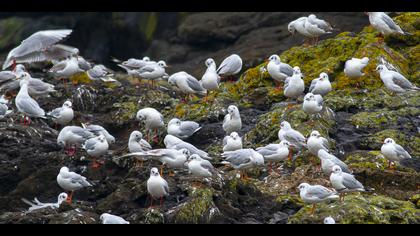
[9,29,72,57]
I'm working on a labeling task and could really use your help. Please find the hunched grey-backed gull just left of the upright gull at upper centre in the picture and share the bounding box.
[168,71,207,102]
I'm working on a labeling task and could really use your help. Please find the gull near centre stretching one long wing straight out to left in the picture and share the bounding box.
[122,148,190,176]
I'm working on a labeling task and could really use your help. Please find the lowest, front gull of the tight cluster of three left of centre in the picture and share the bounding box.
[82,135,109,168]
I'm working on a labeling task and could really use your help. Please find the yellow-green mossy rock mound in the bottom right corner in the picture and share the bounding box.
[288,193,420,224]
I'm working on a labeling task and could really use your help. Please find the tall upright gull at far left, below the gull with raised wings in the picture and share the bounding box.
[15,80,45,125]
